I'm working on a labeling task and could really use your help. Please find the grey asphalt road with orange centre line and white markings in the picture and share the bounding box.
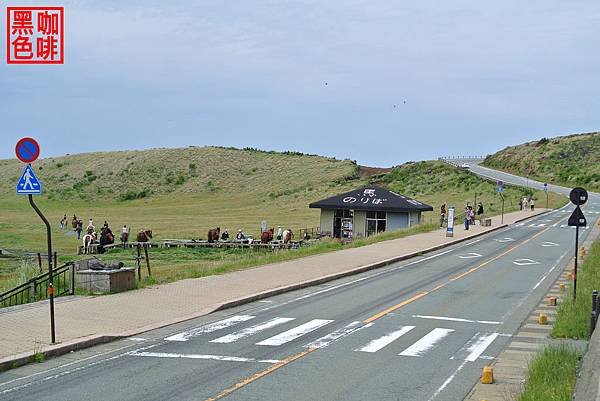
[0,188,600,401]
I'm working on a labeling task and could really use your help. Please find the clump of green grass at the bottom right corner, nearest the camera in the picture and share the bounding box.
[519,345,581,401]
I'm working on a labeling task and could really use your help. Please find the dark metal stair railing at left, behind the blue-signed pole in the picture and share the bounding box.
[0,262,75,307]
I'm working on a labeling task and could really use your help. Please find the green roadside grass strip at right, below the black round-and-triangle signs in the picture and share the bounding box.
[552,240,600,338]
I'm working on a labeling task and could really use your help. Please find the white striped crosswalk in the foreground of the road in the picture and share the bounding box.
[154,315,506,363]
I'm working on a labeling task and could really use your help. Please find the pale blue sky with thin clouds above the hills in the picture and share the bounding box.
[0,0,600,166]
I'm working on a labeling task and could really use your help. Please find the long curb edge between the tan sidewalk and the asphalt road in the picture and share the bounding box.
[0,210,552,372]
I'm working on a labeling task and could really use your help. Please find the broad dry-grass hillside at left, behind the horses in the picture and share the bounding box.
[0,147,359,200]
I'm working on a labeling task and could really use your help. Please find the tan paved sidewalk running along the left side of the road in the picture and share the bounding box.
[0,209,546,370]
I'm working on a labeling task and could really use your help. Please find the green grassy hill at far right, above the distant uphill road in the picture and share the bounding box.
[484,132,600,191]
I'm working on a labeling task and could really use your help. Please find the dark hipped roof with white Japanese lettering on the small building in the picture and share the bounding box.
[308,185,433,212]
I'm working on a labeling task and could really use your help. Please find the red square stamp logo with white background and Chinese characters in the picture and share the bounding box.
[6,7,65,64]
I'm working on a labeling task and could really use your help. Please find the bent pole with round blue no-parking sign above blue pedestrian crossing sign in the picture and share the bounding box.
[15,138,56,344]
